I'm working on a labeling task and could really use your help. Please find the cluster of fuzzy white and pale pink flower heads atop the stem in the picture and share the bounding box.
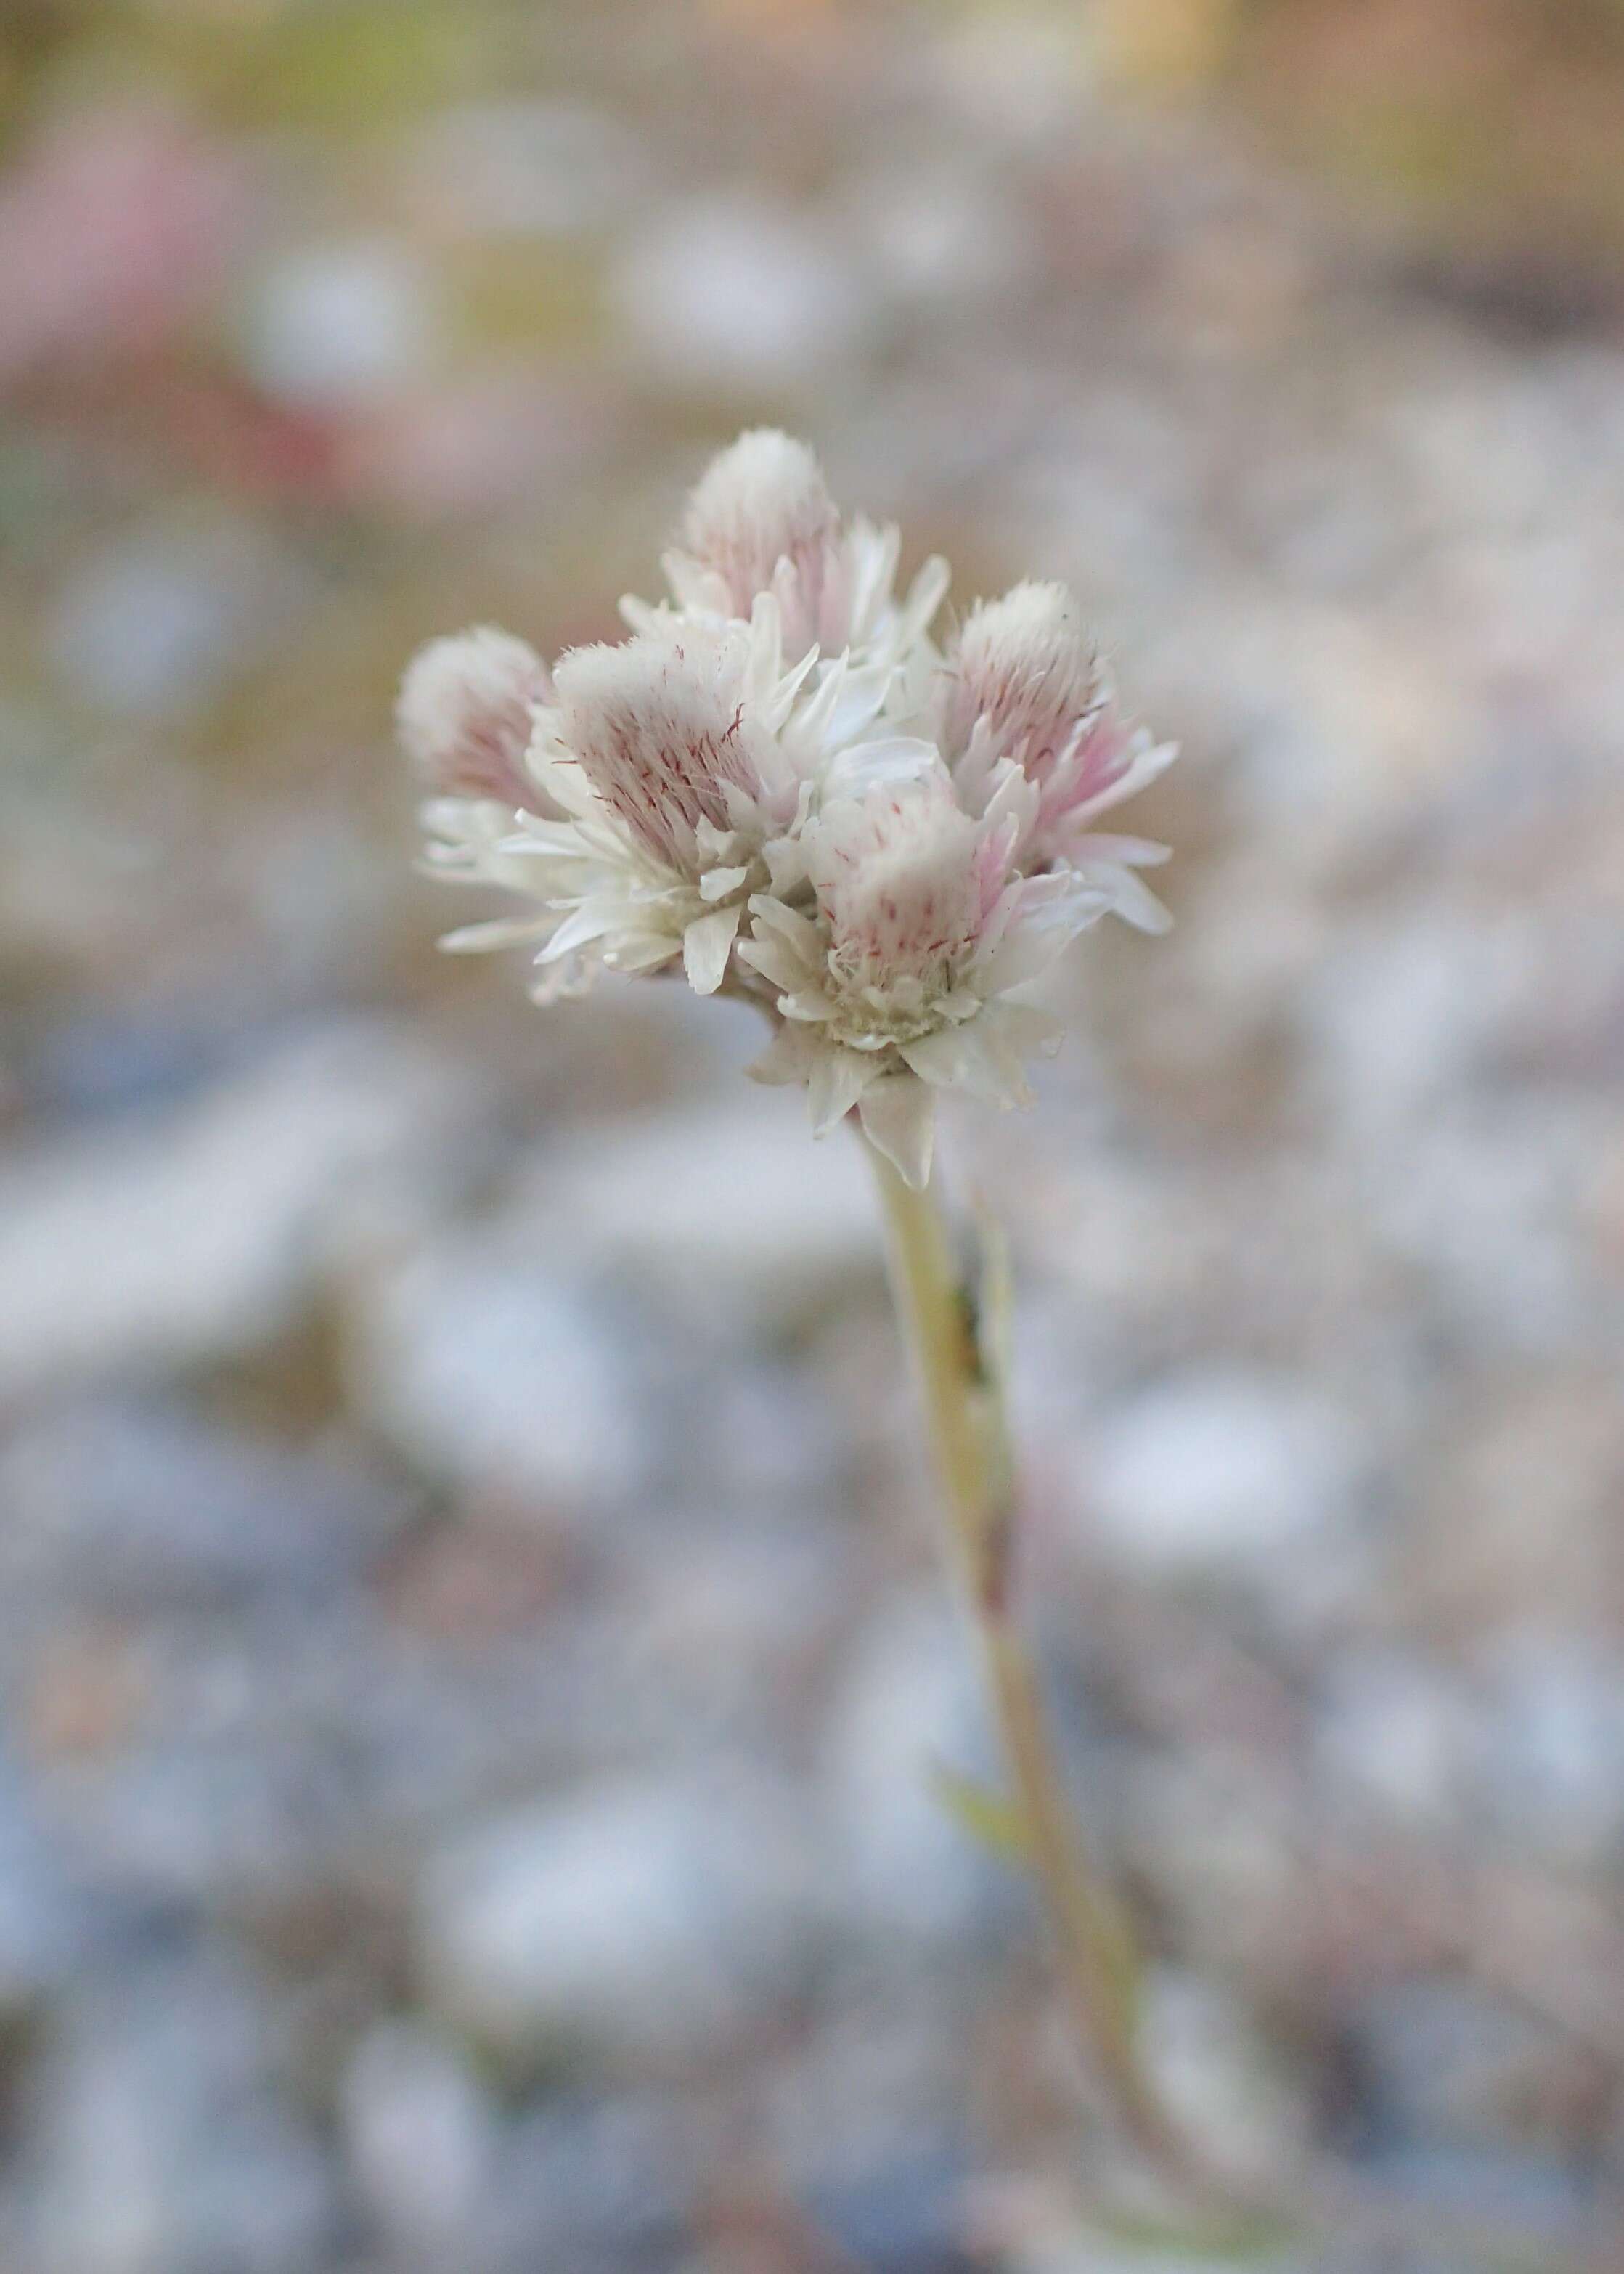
[398,430,1174,1185]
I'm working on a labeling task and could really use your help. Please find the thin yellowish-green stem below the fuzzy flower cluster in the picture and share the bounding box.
[865,1139,1210,2192]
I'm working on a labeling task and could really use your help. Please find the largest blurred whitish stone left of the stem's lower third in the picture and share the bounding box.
[418,1772,807,2065]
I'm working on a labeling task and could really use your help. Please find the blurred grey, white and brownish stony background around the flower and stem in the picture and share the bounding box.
[0,0,1624,2274]
